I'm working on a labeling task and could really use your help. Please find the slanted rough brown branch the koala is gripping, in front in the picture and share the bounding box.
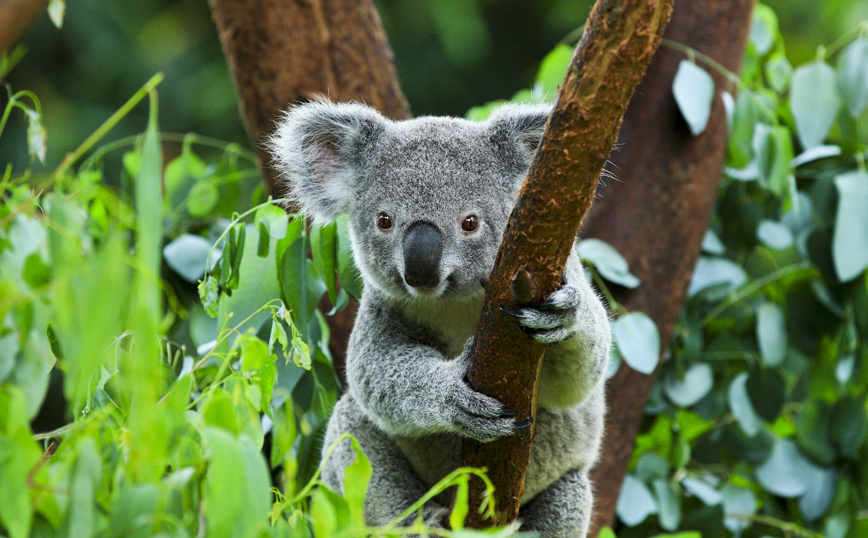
[462,0,673,528]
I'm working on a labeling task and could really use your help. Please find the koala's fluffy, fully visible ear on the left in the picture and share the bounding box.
[267,101,389,222]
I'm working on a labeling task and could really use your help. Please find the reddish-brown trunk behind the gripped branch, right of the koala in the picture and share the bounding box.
[583,0,753,536]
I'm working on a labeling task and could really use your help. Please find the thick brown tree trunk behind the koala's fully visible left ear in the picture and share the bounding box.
[209,0,410,366]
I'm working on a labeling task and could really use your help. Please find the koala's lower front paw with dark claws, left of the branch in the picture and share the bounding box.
[447,358,533,443]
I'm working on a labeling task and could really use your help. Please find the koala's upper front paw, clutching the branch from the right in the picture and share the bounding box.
[500,284,581,345]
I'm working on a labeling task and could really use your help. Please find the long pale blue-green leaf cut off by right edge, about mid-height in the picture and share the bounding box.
[832,171,868,282]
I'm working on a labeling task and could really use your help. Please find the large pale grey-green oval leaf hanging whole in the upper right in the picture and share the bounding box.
[790,60,841,149]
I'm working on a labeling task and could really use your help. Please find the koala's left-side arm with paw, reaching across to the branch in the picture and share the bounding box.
[347,301,529,442]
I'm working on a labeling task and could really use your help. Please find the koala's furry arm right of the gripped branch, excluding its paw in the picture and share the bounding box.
[539,251,612,409]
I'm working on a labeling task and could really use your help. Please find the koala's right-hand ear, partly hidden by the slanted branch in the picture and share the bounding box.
[486,104,552,172]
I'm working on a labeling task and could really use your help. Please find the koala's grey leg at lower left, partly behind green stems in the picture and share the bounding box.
[322,394,448,526]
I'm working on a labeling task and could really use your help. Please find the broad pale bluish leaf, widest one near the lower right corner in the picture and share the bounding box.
[756,439,817,498]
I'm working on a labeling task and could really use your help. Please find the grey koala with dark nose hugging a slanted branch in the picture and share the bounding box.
[269,101,611,538]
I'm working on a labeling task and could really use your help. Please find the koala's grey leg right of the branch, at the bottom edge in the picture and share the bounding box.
[518,469,594,538]
